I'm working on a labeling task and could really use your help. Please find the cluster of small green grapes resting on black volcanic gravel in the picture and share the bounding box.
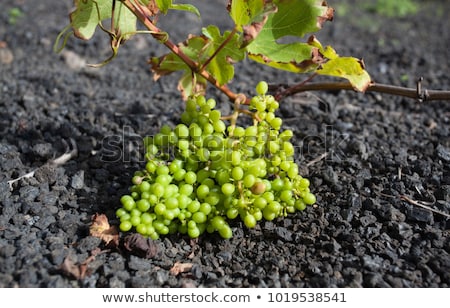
[116,82,316,239]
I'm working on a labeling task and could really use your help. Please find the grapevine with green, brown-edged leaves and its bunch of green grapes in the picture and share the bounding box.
[54,0,371,239]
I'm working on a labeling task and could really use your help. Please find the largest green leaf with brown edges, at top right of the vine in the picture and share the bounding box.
[246,0,334,73]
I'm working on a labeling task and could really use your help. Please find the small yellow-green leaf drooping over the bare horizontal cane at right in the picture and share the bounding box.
[317,57,371,92]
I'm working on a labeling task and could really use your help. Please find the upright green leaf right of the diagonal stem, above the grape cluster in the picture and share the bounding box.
[202,26,245,85]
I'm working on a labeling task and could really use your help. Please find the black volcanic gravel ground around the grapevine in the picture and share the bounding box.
[0,0,450,288]
